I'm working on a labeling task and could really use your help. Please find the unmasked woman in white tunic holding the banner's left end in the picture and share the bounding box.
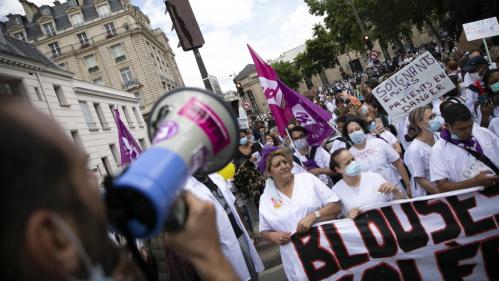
[259,150,341,280]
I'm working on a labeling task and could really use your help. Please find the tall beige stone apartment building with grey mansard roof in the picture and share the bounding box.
[3,0,184,114]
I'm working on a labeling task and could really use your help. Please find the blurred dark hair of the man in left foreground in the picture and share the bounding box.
[0,99,83,280]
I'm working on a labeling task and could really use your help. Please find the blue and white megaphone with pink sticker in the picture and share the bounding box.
[106,88,239,238]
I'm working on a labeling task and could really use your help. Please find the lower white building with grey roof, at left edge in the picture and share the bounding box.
[0,30,149,182]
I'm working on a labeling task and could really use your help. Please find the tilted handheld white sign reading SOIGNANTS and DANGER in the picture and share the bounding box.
[372,51,454,120]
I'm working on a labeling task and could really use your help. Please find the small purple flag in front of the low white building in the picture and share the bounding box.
[114,108,142,166]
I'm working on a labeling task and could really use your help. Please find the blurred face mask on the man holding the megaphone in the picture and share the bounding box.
[52,214,113,281]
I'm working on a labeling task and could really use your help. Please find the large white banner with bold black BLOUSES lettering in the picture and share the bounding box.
[287,188,499,281]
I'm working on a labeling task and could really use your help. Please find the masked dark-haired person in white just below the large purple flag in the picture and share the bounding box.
[290,126,332,185]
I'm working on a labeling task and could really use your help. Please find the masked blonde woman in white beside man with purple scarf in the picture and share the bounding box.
[404,107,442,198]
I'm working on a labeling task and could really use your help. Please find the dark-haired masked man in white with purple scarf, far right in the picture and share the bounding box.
[430,103,499,192]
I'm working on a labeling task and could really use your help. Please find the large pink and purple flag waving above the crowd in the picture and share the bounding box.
[248,45,334,145]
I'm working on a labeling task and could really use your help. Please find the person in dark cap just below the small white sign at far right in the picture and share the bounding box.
[462,56,488,119]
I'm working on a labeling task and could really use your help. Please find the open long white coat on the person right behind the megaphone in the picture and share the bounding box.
[185,174,264,281]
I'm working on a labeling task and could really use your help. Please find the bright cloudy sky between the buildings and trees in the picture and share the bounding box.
[0,0,321,92]
